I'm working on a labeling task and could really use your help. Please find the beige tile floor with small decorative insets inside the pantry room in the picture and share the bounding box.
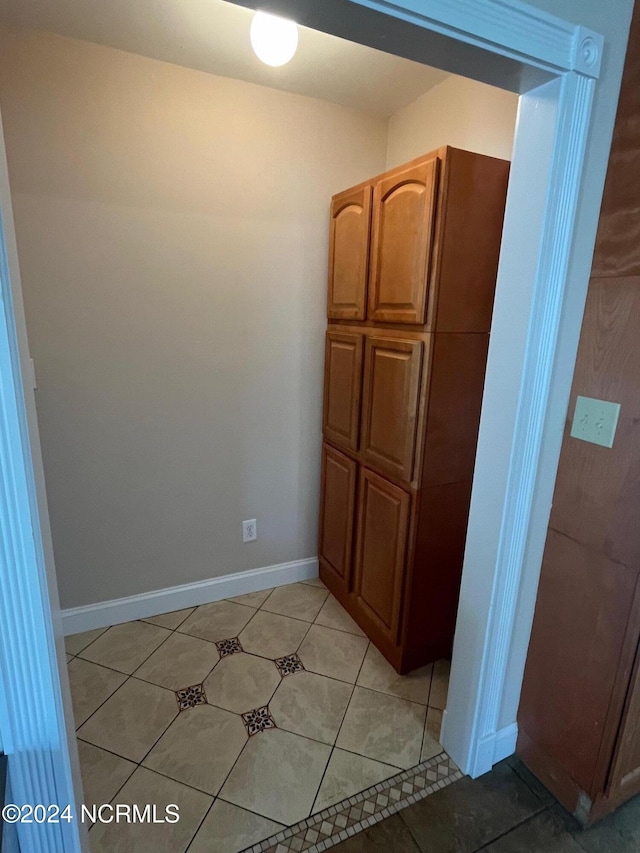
[67,579,450,853]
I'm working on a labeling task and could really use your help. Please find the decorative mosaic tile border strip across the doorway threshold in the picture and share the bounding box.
[244,752,463,853]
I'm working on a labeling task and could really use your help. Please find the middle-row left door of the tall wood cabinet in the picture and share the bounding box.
[323,332,363,451]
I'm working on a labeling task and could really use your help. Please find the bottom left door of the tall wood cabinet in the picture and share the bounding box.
[318,444,357,592]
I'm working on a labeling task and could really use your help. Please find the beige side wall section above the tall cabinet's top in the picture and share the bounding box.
[387,76,518,169]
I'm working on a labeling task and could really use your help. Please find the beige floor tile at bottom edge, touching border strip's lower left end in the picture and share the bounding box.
[189,800,284,853]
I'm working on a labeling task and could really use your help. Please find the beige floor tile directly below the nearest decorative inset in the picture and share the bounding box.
[220,729,331,825]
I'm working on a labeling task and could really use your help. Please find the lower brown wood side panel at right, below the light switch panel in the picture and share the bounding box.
[518,530,637,792]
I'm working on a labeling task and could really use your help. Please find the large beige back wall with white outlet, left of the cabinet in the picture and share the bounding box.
[0,34,386,607]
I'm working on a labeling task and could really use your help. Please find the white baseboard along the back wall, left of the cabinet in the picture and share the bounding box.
[62,557,318,636]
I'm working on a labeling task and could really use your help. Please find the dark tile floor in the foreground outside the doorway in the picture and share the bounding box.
[332,758,640,853]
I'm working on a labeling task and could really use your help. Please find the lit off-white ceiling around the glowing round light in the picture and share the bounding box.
[0,0,447,117]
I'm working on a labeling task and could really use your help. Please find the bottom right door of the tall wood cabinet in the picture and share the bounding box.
[354,468,411,643]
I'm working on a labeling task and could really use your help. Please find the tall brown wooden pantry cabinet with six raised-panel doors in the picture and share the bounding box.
[319,147,509,672]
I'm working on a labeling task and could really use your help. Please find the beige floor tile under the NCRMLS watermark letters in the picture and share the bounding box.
[89,767,213,853]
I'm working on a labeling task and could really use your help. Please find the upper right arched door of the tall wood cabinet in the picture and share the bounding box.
[368,157,440,323]
